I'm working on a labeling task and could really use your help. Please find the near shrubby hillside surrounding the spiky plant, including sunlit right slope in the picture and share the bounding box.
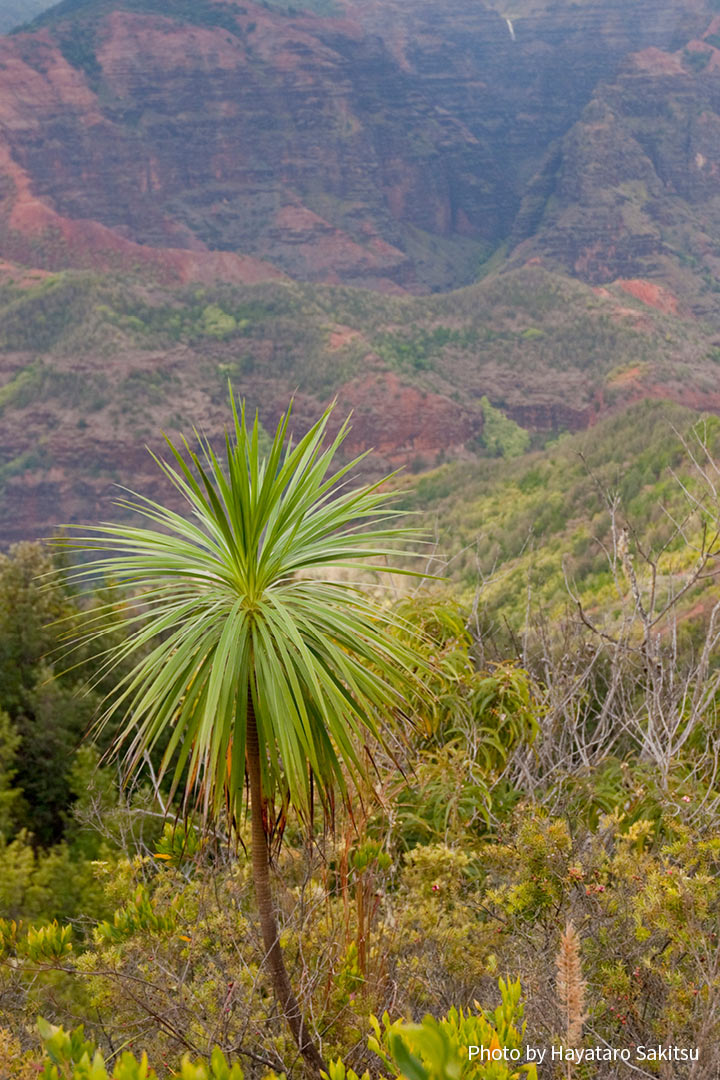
[0,404,720,1080]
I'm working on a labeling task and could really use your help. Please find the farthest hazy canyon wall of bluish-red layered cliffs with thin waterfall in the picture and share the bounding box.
[0,0,720,292]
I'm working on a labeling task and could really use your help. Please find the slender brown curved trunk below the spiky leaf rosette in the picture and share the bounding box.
[245,702,326,1074]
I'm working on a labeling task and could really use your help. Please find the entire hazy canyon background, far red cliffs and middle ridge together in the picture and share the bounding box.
[0,0,720,542]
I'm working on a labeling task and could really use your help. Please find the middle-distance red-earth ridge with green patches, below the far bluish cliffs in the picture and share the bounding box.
[0,267,720,545]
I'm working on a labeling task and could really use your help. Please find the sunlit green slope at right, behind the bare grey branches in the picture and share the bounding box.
[408,402,720,625]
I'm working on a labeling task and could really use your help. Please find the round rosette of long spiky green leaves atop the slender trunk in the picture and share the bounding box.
[60,402,422,829]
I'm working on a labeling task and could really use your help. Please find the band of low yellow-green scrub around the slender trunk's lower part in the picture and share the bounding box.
[0,768,720,1080]
